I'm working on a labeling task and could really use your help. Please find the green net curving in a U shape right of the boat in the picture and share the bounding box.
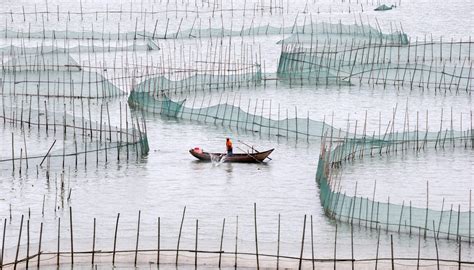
[316,125,474,242]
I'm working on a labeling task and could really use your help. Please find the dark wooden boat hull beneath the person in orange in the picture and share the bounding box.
[189,148,274,163]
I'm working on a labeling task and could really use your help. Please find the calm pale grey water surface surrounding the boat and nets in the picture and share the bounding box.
[0,0,474,268]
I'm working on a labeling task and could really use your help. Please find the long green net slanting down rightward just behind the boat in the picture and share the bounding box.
[128,91,354,140]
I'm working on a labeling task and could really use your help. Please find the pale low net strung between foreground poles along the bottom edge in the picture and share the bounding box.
[0,248,474,269]
